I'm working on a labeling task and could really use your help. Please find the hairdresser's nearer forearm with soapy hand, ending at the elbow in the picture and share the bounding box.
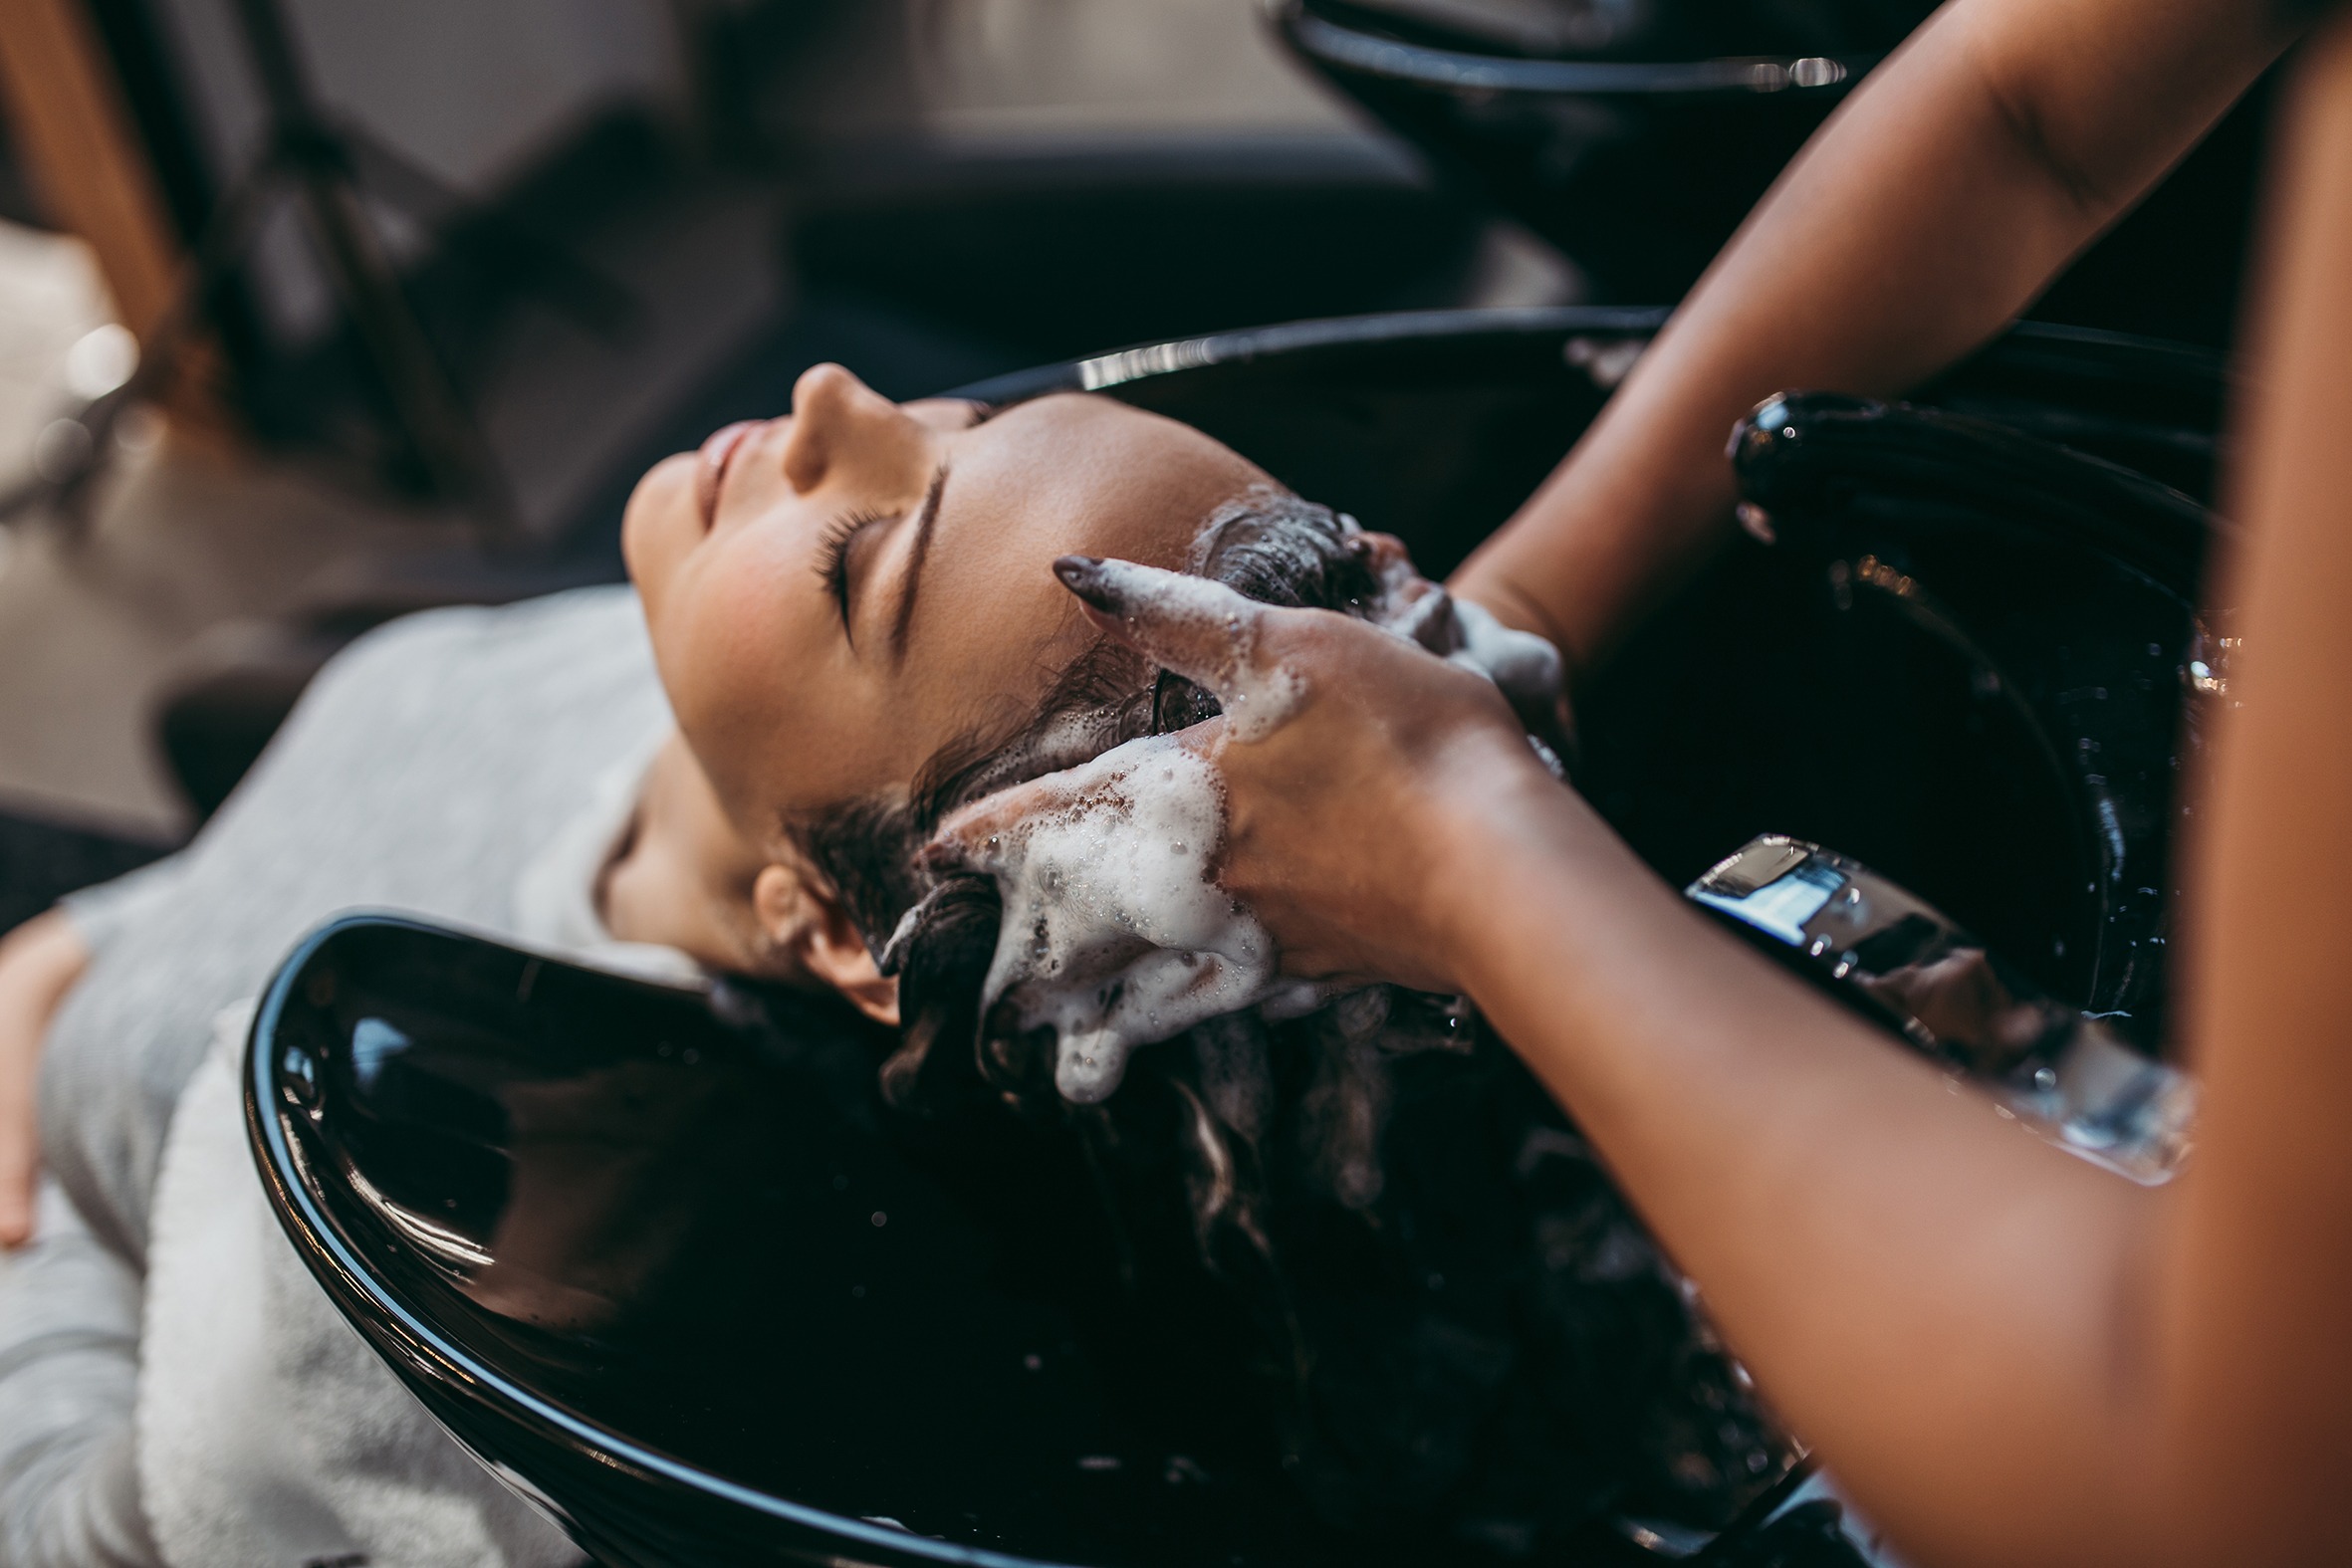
[1040,575,2173,1568]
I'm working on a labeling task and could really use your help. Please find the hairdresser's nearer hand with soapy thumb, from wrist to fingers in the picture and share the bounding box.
[1057,558,1568,990]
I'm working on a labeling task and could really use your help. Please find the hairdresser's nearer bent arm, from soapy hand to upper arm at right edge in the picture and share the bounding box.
[1030,33,2352,1568]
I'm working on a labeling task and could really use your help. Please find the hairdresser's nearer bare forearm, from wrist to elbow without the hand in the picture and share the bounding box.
[1411,783,2157,1563]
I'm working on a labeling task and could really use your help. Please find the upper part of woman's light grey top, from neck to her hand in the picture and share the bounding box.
[40,587,668,1262]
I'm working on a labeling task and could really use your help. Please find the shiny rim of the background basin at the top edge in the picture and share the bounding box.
[1278,0,1877,97]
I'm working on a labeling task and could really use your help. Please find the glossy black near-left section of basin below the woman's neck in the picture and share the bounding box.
[247,917,1430,1568]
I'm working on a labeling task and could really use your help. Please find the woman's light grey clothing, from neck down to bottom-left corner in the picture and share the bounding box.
[0,587,670,1568]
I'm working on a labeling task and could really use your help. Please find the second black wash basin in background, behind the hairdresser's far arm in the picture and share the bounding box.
[1268,0,2267,345]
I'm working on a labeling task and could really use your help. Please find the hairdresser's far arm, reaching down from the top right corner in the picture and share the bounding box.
[1454,0,2312,670]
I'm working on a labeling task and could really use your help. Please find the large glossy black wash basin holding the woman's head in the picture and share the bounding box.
[247,311,2225,1568]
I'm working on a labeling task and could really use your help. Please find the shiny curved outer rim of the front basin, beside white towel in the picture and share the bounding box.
[245,915,1081,1568]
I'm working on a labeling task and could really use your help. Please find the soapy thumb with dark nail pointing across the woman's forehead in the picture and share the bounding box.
[1054,555,1305,741]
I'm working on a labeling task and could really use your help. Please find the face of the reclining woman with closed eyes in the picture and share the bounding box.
[623,364,1268,841]
